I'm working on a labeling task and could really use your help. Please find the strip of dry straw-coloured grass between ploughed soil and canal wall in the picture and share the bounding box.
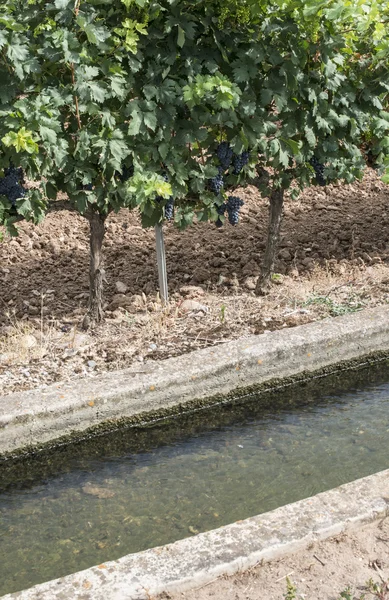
[0,261,389,393]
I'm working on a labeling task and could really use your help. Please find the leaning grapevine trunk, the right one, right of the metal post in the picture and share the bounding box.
[255,189,284,296]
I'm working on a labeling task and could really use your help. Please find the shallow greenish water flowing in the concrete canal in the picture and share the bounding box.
[0,367,389,595]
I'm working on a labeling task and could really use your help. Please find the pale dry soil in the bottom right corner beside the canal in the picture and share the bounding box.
[160,518,389,600]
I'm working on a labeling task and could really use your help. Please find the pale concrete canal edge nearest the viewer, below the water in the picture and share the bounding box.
[2,470,389,600]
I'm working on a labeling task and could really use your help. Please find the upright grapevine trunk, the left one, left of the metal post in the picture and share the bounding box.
[85,211,107,324]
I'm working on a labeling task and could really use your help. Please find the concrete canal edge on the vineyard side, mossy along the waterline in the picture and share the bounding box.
[0,307,389,459]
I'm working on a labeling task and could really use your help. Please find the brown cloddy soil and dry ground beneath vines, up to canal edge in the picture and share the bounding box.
[0,170,389,394]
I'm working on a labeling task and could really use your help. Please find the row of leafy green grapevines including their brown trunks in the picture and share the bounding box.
[0,0,389,321]
